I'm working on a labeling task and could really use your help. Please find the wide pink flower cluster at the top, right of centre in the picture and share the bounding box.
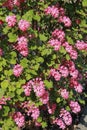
[44,6,59,18]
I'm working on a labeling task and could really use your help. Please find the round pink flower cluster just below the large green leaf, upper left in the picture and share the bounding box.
[18,19,30,31]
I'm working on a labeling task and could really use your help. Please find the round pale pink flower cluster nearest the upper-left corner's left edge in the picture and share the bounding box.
[6,15,17,27]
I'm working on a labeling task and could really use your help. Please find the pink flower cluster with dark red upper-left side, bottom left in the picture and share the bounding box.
[13,112,25,128]
